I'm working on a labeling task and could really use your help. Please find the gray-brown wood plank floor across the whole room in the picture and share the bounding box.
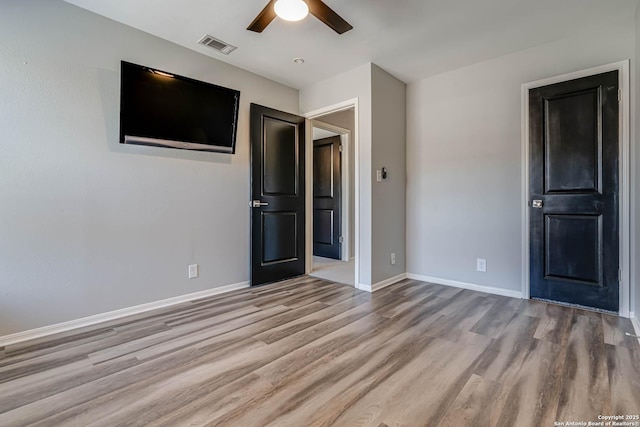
[0,277,640,427]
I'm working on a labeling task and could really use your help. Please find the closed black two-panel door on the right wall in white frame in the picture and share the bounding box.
[529,71,619,311]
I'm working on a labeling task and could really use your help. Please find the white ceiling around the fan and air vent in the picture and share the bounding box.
[65,0,638,88]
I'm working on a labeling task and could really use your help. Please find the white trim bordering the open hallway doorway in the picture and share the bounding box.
[303,98,360,287]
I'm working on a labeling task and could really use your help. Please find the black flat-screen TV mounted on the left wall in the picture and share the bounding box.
[120,61,240,153]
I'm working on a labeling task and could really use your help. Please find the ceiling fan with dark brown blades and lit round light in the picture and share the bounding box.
[247,0,353,34]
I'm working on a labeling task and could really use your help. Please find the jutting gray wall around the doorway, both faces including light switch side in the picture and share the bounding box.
[300,64,406,286]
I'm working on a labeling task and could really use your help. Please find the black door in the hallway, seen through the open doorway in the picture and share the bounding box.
[313,136,342,259]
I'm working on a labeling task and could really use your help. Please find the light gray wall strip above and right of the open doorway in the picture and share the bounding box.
[300,64,372,285]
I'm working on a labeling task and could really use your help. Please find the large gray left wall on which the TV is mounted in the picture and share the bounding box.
[0,0,298,335]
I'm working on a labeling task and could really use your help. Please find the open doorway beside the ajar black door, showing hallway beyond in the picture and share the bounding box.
[307,101,358,287]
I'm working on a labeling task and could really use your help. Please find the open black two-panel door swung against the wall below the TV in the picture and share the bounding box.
[250,104,305,286]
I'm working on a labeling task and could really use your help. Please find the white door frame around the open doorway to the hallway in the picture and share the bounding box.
[303,98,360,287]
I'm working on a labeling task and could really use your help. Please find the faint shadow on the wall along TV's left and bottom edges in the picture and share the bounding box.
[98,69,231,164]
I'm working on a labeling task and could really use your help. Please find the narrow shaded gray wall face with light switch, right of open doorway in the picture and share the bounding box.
[371,65,407,283]
